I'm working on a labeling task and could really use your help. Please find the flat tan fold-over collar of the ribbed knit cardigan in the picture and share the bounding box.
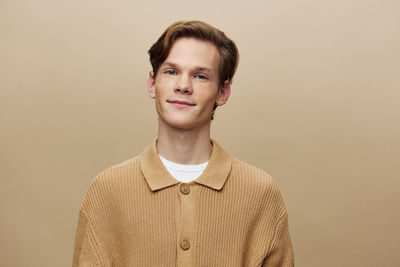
[139,139,232,191]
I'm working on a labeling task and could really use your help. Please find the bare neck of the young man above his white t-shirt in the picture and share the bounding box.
[157,122,212,164]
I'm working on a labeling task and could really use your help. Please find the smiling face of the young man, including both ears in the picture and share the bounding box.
[147,38,230,130]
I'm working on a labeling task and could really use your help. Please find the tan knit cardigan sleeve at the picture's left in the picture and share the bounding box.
[72,209,105,267]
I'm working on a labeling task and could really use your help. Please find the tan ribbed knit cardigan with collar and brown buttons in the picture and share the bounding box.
[73,140,294,267]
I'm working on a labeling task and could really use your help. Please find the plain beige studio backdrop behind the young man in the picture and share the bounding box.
[0,0,400,267]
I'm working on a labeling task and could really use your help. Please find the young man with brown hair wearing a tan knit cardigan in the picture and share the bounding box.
[73,21,294,267]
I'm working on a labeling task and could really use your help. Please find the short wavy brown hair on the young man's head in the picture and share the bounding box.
[148,21,239,119]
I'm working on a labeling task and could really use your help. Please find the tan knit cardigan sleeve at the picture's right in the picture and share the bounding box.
[262,212,294,267]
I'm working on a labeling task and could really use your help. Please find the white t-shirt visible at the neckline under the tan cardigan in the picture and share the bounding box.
[159,155,208,183]
